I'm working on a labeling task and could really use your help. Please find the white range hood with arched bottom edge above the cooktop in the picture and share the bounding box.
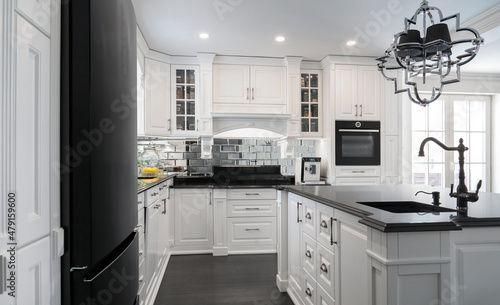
[212,113,290,138]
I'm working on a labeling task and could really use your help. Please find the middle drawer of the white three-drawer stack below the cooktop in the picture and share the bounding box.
[227,199,276,217]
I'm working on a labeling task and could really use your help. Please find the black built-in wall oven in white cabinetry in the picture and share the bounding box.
[335,121,380,165]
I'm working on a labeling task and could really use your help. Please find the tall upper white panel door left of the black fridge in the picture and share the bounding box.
[15,14,53,245]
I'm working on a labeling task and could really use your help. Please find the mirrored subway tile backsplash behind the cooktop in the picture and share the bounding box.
[138,139,316,175]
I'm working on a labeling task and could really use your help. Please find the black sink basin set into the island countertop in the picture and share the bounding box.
[358,201,456,213]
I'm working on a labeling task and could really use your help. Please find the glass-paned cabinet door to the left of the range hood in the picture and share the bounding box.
[172,66,199,135]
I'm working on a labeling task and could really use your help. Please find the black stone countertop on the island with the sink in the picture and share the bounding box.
[282,185,500,232]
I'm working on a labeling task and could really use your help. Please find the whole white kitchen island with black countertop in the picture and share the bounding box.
[277,185,500,305]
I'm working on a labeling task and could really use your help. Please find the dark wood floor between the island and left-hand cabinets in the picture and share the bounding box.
[154,254,293,305]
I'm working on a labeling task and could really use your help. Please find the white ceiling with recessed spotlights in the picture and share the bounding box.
[132,0,500,73]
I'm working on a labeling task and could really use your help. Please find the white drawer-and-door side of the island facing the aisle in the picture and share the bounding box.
[287,193,368,305]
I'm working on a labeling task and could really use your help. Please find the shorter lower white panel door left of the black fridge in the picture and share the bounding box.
[17,237,51,305]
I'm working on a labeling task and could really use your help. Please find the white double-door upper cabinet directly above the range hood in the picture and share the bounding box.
[212,65,287,114]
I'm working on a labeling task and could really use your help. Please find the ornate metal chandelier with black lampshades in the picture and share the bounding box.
[377,0,484,106]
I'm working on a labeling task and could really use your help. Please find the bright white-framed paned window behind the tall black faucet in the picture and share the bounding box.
[411,95,491,190]
